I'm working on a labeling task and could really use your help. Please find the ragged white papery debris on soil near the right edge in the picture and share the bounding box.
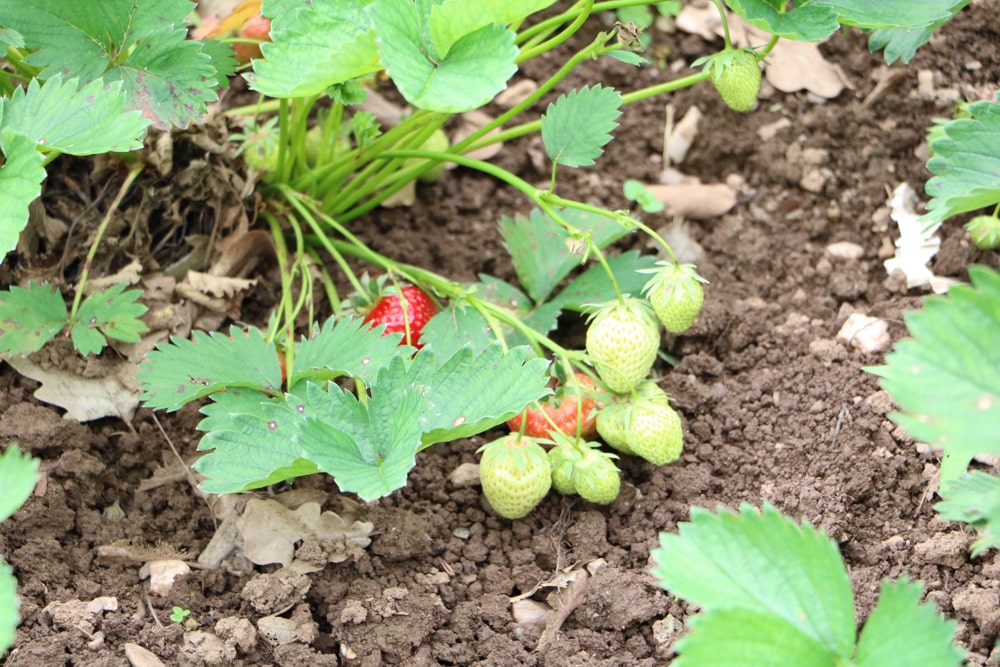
[884,183,947,292]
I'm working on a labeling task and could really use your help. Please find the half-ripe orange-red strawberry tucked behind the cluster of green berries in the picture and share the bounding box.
[507,373,600,440]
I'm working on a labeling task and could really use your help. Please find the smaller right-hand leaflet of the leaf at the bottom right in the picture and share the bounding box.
[853,579,965,667]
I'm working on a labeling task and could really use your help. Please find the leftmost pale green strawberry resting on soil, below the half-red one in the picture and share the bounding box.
[479,433,552,519]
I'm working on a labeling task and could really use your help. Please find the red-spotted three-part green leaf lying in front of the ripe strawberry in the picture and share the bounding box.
[137,319,548,500]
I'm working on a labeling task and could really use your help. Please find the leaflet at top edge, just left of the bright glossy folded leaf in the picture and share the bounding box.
[246,0,382,97]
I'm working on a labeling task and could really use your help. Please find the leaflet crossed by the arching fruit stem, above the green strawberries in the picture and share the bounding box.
[500,209,628,303]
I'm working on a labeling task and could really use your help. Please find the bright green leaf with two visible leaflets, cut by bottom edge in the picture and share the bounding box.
[652,504,962,667]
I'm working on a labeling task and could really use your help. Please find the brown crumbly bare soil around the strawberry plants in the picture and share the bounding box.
[0,6,1000,667]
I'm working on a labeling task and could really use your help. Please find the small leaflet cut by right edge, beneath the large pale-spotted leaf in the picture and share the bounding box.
[934,470,1000,557]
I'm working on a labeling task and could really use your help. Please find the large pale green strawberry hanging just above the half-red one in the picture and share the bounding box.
[587,297,660,394]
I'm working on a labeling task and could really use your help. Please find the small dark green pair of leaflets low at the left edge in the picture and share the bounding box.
[0,282,146,354]
